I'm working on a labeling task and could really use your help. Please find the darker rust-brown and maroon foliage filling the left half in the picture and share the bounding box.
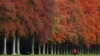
[0,0,54,43]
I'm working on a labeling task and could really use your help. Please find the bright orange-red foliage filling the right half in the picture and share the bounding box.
[51,0,100,47]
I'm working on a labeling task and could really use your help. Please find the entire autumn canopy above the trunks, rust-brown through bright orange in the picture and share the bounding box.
[0,0,100,47]
